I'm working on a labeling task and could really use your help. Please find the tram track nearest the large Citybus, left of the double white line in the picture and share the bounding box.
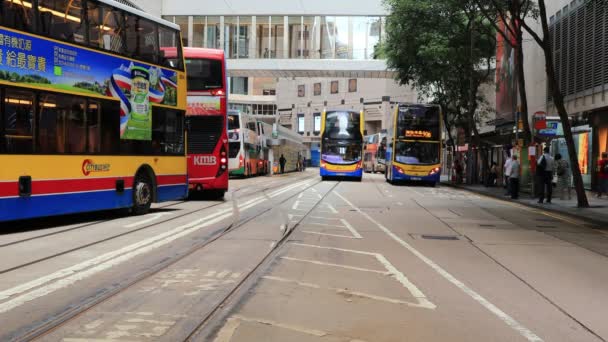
[0,177,314,275]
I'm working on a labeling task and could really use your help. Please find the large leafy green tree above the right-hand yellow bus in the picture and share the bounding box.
[383,0,496,181]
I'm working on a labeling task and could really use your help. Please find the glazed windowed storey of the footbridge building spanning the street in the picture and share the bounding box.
[163,15,385,60]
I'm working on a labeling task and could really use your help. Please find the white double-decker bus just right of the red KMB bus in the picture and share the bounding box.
[228,110,264,177]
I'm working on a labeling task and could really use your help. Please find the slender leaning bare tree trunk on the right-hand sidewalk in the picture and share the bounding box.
[522,0,589,208]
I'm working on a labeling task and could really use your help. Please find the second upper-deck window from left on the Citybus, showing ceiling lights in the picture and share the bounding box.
[38,0,85,43]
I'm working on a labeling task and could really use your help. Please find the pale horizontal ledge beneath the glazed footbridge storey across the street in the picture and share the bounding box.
[226,59,396,79]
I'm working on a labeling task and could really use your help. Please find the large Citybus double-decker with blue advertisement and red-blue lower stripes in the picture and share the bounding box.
[0,0,188,221]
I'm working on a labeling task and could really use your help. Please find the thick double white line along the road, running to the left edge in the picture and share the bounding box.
[0,181,310,313]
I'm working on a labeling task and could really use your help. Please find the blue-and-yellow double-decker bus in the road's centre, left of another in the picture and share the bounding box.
[321,110,365,181]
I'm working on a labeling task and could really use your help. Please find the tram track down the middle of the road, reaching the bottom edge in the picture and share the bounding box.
[11,177,328,341]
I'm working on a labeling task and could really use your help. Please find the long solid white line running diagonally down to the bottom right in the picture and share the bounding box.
[334,192,543,342]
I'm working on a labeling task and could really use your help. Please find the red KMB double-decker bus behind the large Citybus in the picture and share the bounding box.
[169,48,228,198]
